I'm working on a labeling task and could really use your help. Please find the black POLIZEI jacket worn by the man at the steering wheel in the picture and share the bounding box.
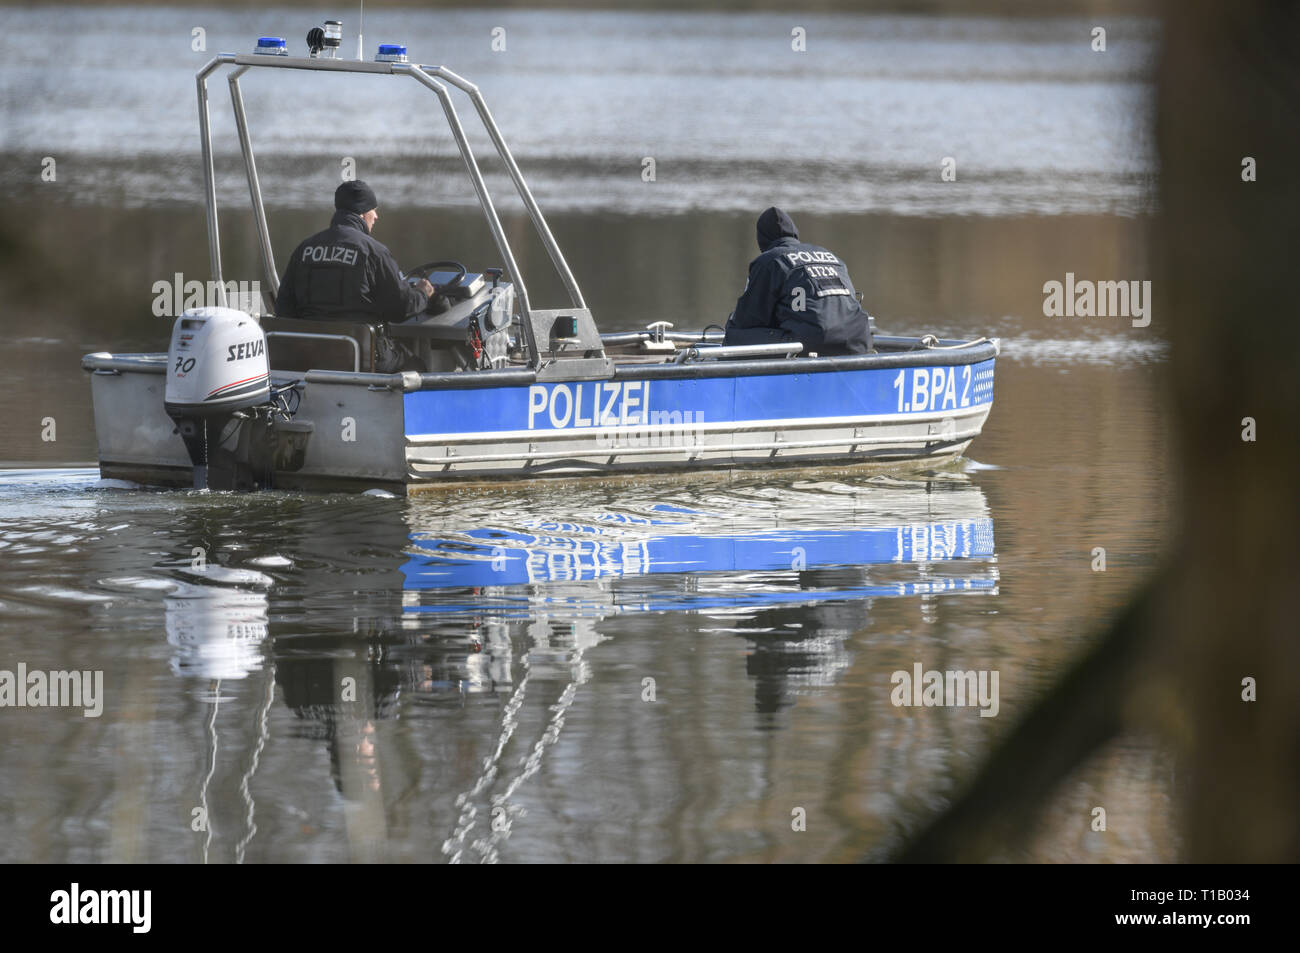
[276,212,429,321]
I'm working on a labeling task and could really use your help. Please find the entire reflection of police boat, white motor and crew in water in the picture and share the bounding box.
[159,471,998,862]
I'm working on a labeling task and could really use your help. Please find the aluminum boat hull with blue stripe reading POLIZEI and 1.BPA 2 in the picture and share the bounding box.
[82,339,997,493]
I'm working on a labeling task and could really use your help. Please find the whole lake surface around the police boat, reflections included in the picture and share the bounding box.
[0,8,1179,862]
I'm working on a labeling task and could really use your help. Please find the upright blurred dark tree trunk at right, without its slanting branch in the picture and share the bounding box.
[1157,0,1300,861]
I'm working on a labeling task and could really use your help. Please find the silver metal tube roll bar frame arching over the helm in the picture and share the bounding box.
[195,53,586,368]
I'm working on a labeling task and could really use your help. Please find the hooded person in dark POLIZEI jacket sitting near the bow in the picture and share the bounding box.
[725,207,871,354]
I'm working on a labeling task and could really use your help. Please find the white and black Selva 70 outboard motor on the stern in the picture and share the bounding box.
[164,308,273,490]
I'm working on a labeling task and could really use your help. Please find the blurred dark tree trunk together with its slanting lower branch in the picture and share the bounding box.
[897,0,1300,862]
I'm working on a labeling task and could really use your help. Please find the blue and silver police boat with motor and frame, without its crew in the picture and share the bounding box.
[82,23,998,494]
